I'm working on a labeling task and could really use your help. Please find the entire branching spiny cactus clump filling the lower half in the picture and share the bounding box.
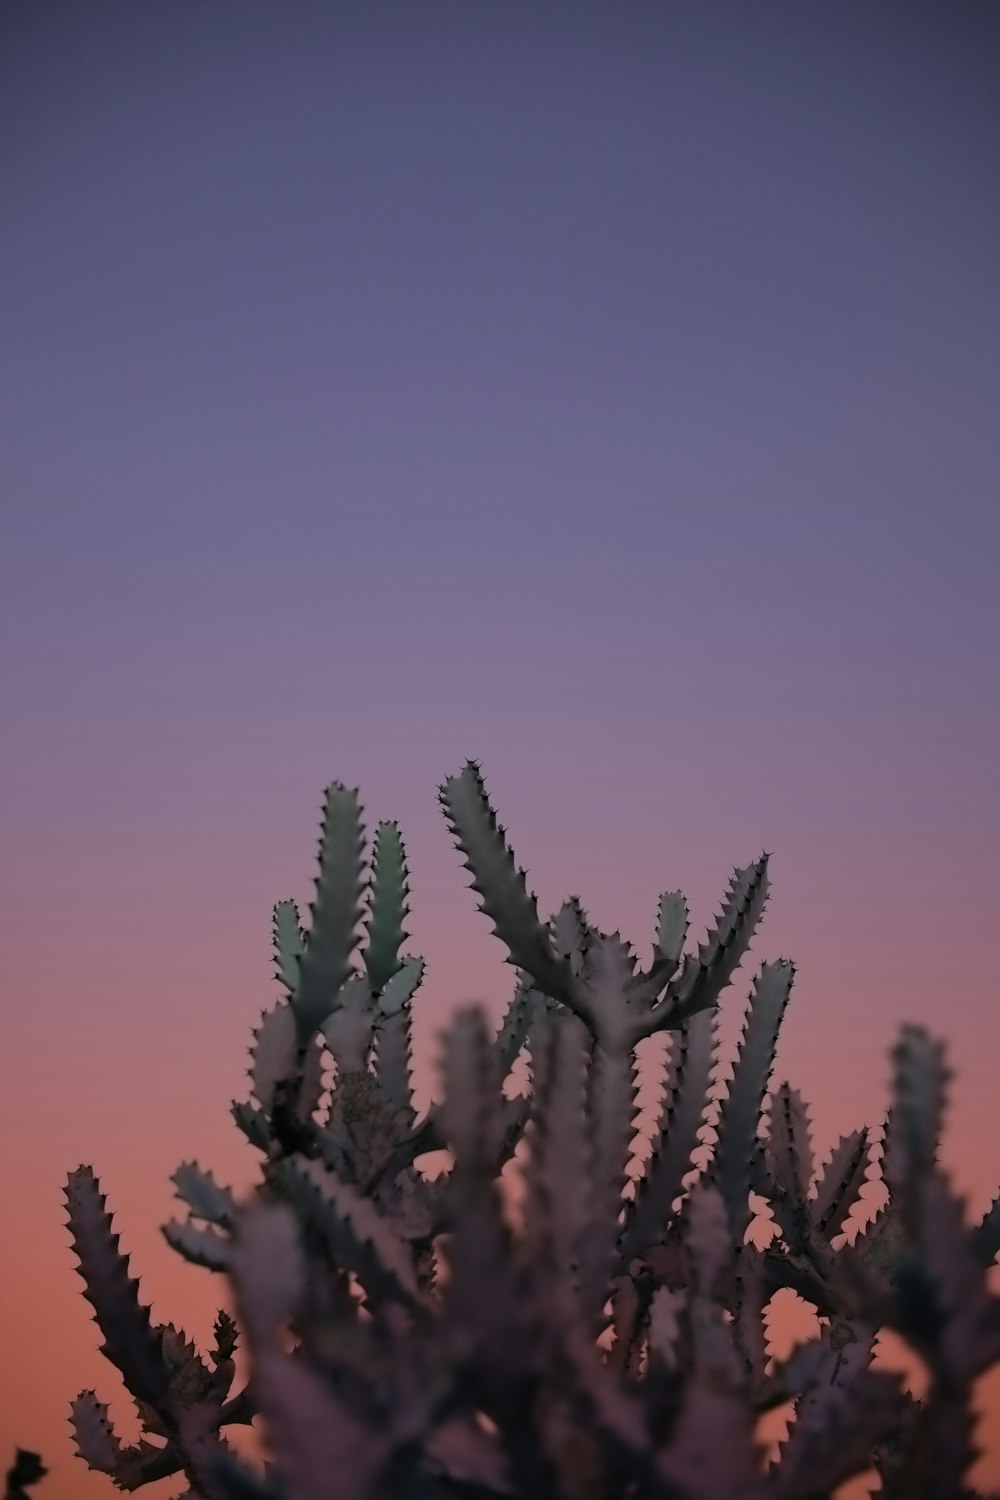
[52,762,1000,1500]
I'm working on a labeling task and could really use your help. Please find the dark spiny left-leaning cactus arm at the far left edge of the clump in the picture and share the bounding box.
[64,1166,169,1407]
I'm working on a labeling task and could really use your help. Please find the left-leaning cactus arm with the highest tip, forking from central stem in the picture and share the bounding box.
[438,761,586,1020]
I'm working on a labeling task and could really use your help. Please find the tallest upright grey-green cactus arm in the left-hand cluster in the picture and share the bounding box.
[292,782,364,1044]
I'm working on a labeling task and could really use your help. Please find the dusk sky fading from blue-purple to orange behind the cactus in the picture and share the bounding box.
[0,0,1000,1500]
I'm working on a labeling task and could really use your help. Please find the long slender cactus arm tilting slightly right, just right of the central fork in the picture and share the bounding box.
[711,959,795,1245]
